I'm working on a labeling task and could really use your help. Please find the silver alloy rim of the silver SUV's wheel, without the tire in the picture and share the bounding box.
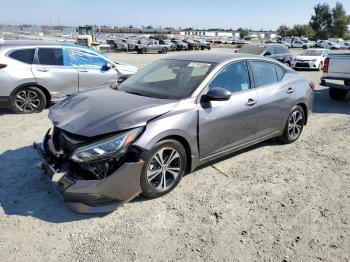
[15,90,41,112]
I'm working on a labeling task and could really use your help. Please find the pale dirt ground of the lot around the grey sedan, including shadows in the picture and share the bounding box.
[0,50,350,261]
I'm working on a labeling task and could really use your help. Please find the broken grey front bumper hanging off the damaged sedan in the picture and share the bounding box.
[34,137,144,213]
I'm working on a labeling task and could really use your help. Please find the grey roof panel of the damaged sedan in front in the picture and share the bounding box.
[162,52,262,64]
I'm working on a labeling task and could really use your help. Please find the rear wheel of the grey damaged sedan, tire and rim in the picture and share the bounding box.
[278,106,305,144]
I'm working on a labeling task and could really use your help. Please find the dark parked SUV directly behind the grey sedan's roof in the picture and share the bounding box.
[236,44,293,66]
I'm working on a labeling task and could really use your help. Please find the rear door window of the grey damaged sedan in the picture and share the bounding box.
[251,61,278,87]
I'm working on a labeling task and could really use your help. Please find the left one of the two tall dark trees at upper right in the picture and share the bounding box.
[310,4,332,39]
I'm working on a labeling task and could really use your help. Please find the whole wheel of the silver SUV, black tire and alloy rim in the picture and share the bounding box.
[9,86,47,114]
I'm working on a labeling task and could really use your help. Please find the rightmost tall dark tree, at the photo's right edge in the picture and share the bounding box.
[332,2,350,38]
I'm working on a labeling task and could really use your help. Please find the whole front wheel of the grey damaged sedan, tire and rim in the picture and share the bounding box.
[140,140,187,198]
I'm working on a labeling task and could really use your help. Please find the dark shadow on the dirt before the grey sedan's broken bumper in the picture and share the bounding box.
[0,146,103,223]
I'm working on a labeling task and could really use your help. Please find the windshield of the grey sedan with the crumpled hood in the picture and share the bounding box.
[118,59,215,99]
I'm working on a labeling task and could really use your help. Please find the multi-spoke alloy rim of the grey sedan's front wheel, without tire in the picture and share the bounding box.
[147,147,181,191]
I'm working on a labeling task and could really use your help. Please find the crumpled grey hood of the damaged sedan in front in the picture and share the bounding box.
[49,88,177,137]
